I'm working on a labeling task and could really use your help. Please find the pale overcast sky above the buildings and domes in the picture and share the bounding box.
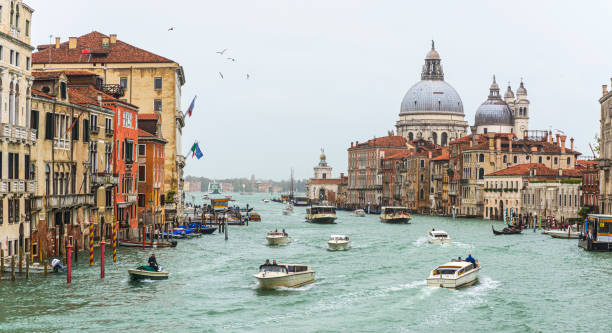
[26,0,612,179]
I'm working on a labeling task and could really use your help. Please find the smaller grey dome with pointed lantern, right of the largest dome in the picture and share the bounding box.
[474,76,514,126]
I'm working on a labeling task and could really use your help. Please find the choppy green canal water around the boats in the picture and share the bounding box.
[0,191,612,332]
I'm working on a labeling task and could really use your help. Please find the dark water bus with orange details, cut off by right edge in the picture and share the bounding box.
[578,214,612,251]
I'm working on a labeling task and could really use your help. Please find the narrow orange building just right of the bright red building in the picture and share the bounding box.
[138,114,168,225]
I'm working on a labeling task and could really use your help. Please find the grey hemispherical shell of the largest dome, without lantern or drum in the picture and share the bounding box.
[400,80,463,115]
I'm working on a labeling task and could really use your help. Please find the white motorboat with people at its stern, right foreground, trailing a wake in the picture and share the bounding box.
[427,259,481,288]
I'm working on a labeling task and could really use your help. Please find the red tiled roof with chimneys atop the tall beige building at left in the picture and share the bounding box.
[32,31,174,64]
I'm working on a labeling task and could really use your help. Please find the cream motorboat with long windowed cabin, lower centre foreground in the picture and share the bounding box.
[253,264,315,289]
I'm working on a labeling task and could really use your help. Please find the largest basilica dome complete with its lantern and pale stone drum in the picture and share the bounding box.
[395,41,468,146]
